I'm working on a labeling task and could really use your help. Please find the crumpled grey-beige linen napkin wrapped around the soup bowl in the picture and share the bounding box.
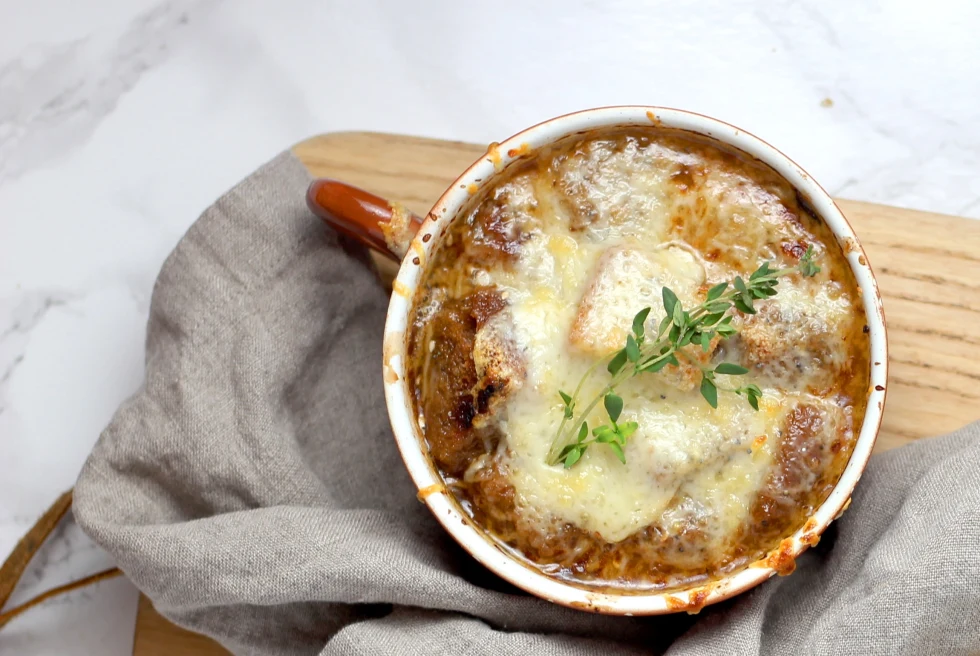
[75,153,980,656]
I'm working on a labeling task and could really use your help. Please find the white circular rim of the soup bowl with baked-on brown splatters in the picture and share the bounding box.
[382,105,888,616]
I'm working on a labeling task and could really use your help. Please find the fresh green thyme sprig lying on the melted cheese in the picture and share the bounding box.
[548,246,820,469]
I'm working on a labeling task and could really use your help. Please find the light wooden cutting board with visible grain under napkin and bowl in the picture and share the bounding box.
[133,132,980,656]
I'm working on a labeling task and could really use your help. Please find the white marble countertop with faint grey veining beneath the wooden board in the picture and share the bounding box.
[0,0,980,656]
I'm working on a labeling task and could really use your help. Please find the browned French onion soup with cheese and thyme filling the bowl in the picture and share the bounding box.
[407,126,869,593]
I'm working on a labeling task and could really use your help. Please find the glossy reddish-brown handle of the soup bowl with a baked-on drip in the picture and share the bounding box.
[306,178,422,262]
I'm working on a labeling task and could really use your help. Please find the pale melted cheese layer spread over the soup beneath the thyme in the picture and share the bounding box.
[460,132,852,548]
